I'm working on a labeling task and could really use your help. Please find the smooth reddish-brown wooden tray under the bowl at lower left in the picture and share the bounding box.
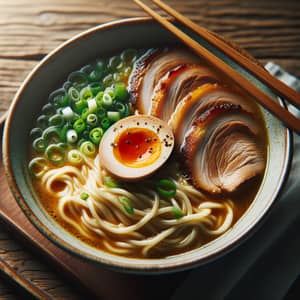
[0,120,188,300]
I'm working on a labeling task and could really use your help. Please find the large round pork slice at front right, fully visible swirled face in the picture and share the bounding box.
[182,104,265,194]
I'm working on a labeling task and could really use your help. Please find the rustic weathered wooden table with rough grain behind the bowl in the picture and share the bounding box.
[0,0,300,299]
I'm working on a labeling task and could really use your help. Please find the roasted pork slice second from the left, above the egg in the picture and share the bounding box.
[150,64,218,121]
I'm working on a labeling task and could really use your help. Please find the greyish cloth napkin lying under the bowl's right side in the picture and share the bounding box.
[172,62,300,300]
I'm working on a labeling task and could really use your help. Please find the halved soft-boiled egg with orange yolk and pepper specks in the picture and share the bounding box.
[99,115,174,180]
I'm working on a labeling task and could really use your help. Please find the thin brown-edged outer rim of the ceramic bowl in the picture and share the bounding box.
[2,17,293,274]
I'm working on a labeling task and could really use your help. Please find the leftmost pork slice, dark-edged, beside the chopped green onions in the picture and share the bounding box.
[128,48,200,114]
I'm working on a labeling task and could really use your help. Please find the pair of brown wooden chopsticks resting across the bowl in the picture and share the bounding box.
[133,0,300,133]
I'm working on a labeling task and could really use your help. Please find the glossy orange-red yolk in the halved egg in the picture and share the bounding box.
[113,128,162,168]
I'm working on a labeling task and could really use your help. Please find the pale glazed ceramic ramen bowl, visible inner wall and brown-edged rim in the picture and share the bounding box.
[3,18,291,273]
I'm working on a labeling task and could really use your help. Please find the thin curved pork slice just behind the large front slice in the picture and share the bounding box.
[168,83,257,149]
